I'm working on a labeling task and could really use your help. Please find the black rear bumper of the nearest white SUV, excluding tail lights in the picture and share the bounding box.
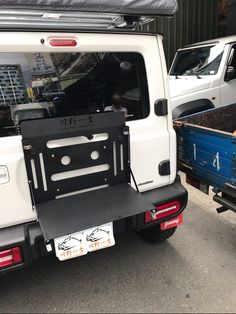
[0,177,187,274]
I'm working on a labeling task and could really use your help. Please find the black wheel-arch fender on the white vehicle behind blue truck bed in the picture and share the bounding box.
[172,99,215,120]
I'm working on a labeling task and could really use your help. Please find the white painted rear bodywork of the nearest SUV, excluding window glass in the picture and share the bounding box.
[0,32,173,228]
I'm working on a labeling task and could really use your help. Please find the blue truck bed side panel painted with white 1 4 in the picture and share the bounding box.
[178,126,236,187]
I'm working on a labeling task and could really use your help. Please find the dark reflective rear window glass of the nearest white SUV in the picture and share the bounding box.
[0,52,149,136]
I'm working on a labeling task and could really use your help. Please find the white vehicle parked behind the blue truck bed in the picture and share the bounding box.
[169,36,236,118]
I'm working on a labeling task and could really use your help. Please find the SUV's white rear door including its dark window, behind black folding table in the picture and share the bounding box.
[0,32,171,231]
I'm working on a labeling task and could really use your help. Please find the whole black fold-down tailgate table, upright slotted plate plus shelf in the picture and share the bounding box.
[21,112,154,240]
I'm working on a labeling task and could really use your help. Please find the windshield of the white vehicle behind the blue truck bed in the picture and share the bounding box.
[170,44,224,76]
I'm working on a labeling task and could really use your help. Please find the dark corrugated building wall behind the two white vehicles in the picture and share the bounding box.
[143,0,226,68]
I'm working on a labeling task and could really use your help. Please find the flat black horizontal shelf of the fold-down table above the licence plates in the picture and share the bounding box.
[37,183,155,240]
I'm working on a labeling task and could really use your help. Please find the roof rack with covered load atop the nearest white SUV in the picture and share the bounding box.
[0,0,178,30]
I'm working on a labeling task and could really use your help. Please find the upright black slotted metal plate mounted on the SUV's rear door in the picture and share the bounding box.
[21,112,130,203]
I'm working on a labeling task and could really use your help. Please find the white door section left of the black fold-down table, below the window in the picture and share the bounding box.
[0,136,36,228]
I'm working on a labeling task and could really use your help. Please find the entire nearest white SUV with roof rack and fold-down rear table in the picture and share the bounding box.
[0,0,187,273]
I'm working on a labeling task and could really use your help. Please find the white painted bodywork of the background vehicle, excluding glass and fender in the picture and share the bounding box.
[168,36,236,110]
